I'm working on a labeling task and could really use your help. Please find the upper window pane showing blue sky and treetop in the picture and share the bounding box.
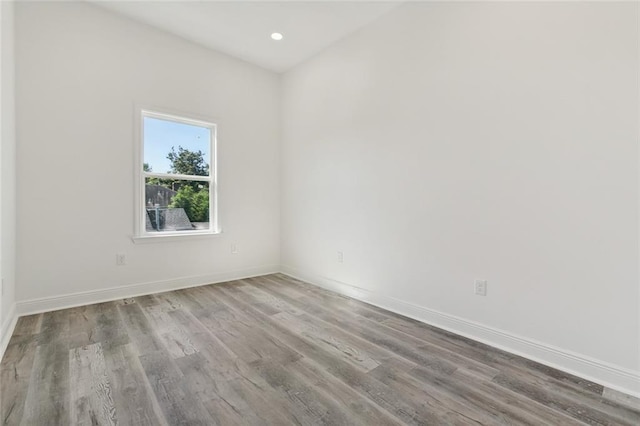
[143,117,211,176]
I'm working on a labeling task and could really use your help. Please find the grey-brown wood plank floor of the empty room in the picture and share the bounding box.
[0,274,640,426]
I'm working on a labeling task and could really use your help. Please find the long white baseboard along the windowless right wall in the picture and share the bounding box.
[281,265,640,397]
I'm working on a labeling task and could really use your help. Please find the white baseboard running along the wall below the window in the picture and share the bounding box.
[16,265,280,316]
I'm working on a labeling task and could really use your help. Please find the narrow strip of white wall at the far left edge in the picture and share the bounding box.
[0,1,16,342]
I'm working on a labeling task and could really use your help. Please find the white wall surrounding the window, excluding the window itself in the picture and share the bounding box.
[16,3,280,304]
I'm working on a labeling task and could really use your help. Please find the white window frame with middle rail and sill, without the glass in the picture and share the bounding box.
[133,107,221,243]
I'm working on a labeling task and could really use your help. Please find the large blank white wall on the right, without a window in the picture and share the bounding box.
[281,3,640,394]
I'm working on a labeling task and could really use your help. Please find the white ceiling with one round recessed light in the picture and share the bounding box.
[93,0,399,72]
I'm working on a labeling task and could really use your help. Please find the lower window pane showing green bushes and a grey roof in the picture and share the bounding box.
[145,178,210,232]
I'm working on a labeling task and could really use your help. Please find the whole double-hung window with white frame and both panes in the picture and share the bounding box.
[136,109,218,237]
